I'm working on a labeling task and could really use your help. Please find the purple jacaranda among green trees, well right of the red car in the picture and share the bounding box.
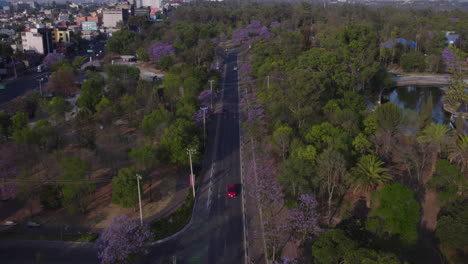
[288,194,320,240]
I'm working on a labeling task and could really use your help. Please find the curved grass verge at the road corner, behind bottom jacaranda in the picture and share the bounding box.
[151,189,195,240]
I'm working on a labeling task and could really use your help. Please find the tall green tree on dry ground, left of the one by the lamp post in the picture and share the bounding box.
[59,157,96,213]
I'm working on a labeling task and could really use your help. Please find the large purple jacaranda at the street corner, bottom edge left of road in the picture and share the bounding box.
[97,214,153,264]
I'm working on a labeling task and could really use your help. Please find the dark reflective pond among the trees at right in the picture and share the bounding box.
[382,86,450,124]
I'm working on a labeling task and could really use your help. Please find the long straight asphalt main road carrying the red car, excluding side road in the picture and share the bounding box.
[145,53,245,264]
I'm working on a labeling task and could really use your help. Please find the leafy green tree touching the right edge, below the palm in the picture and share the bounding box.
[429,160,468,204]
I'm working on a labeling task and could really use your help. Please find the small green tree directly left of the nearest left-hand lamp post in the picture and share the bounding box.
[112,168,141,208]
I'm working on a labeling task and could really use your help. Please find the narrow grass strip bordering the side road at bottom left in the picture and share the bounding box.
[0,233,98,242]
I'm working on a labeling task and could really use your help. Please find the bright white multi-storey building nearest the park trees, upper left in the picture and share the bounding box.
[21,28,52,55]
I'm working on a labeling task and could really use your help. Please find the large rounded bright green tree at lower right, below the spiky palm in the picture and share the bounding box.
[366,184,420,246]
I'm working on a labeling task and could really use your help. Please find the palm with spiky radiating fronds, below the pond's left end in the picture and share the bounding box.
[352,154,391,192]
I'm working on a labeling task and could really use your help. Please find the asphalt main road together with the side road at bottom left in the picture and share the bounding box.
[0,53,245,264]
